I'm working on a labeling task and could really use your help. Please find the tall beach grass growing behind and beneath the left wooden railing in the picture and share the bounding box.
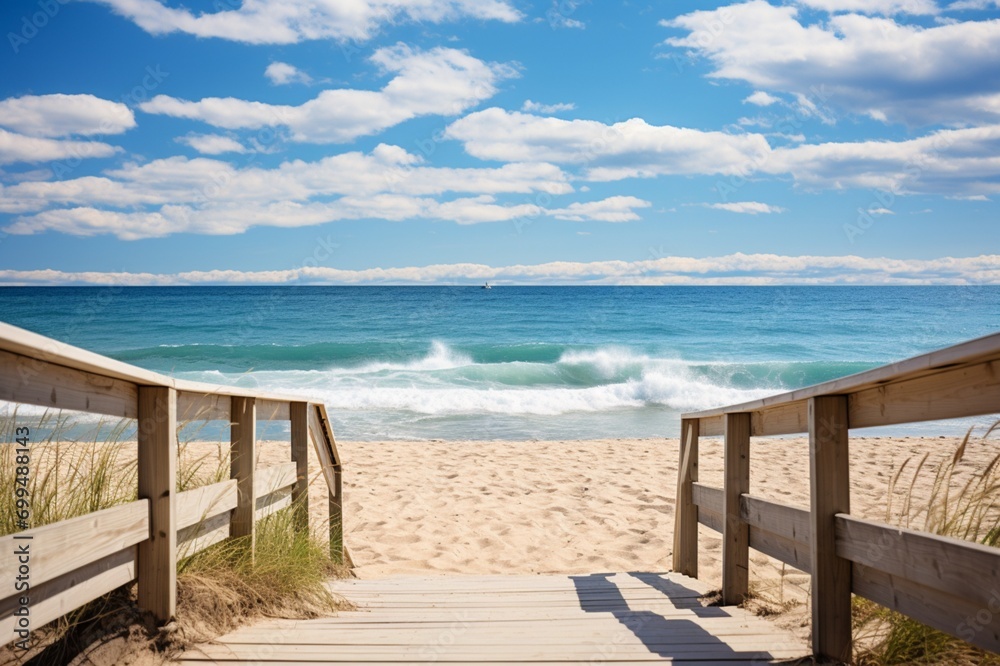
[0,407,348,665]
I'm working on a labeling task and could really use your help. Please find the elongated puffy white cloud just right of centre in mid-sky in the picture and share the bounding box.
[445,108,770,180]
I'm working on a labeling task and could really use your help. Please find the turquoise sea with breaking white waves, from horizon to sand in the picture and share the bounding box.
[0,286,1000,439]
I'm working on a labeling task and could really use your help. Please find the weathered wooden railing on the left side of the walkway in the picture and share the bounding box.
[0,324,350,644]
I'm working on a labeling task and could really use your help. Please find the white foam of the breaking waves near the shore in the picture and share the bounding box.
[180,342,774,415]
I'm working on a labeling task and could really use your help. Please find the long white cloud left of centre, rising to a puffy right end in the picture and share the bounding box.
[140,44,516,143]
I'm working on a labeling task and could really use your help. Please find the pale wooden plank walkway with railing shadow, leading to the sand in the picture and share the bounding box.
[179,573,809,666]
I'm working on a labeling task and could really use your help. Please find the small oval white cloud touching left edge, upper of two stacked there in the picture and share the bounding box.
[0,94,135,138]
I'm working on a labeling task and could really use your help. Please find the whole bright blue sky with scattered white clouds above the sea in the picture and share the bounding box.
[0,0,1000,284]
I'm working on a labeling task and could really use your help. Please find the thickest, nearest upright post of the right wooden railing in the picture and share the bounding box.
[809,395,851,662]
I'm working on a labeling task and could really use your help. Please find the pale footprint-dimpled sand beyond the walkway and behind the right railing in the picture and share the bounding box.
[322,437,996,635]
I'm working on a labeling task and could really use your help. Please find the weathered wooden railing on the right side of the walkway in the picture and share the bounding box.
[673,334,1000,661]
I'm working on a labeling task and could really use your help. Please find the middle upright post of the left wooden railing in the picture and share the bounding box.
[229,396,257,548]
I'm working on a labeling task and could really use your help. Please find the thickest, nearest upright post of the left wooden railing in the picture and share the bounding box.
[136,386,177,622]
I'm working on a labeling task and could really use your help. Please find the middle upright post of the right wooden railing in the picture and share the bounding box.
[722,412,750,606]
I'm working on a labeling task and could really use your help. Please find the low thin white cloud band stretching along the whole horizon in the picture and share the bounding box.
[0,254,1000,285]
